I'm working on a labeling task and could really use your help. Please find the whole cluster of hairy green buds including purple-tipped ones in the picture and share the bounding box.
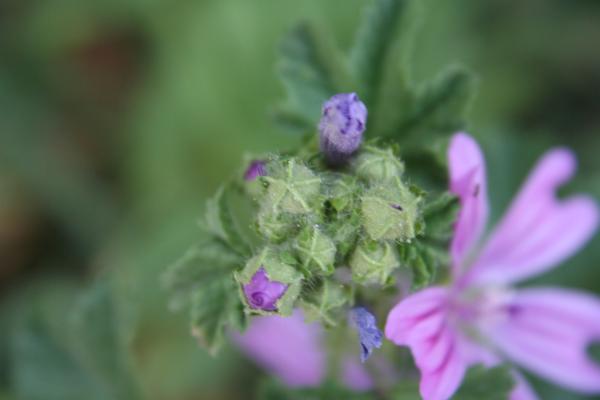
[236,93,420,315]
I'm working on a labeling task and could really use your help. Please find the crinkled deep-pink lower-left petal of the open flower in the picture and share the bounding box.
[385,287,482,400]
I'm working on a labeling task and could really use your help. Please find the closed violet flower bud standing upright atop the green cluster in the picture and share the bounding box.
[319,93,367,165]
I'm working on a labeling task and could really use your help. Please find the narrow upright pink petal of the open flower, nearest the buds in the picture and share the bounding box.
[448,133,488,276]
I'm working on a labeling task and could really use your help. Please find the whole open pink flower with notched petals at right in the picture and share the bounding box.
[385,133,600,400]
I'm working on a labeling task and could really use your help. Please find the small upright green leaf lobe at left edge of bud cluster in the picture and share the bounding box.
[206,185,250,256]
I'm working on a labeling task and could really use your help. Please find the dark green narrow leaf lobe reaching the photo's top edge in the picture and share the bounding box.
[350,0,408,106]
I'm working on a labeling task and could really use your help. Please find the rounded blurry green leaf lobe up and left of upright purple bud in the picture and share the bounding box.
[277,24,351,130]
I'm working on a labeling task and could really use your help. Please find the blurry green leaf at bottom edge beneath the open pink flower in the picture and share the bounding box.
[452,365,515,400]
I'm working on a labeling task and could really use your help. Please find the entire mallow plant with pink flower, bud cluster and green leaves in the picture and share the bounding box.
[164,0,600,400]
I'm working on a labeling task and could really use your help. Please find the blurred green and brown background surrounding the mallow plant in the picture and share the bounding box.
[0,0,600,400]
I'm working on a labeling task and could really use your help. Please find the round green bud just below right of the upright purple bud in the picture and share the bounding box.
[354,146,404,183]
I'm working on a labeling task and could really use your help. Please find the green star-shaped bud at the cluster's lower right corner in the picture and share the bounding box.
[350,241,400,285]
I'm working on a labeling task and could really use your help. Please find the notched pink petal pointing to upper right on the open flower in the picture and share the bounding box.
[468,149,598,284]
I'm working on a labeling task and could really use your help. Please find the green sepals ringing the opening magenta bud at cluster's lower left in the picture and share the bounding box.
[234,247,303,316]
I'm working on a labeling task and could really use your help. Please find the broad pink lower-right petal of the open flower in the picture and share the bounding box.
[485,289,600,393]
